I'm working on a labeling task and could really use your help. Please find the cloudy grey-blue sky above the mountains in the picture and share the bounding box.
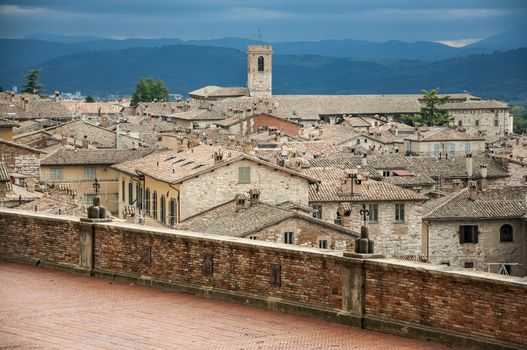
[0,0,527,46]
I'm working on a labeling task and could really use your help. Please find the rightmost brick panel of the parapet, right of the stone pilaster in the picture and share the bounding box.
[365,261,527,344]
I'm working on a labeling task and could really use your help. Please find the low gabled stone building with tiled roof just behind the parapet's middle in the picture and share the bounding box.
[176,190,358,251]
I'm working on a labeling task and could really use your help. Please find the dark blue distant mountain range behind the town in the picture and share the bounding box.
[0,31,527,100]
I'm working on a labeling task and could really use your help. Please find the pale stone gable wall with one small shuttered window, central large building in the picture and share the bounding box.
[180,160,309,220]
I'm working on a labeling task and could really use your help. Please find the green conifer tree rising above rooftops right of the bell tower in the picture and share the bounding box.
[401,89,454,126]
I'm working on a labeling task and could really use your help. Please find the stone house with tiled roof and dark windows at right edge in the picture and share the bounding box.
[423,182,527,276]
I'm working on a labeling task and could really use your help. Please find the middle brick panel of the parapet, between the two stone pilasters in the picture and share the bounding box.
[94,225,344,308]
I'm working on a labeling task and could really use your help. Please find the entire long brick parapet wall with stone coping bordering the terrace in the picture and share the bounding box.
[0,209,527,349]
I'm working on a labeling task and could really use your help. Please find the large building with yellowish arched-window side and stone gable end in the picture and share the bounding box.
[113,145,318,226]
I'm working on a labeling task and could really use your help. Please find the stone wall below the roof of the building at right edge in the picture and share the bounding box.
[423,219,527,276]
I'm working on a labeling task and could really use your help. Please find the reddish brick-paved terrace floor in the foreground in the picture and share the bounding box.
[0,262,446,349]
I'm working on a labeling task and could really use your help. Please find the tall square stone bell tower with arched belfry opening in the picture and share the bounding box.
[247,45,273,97]
